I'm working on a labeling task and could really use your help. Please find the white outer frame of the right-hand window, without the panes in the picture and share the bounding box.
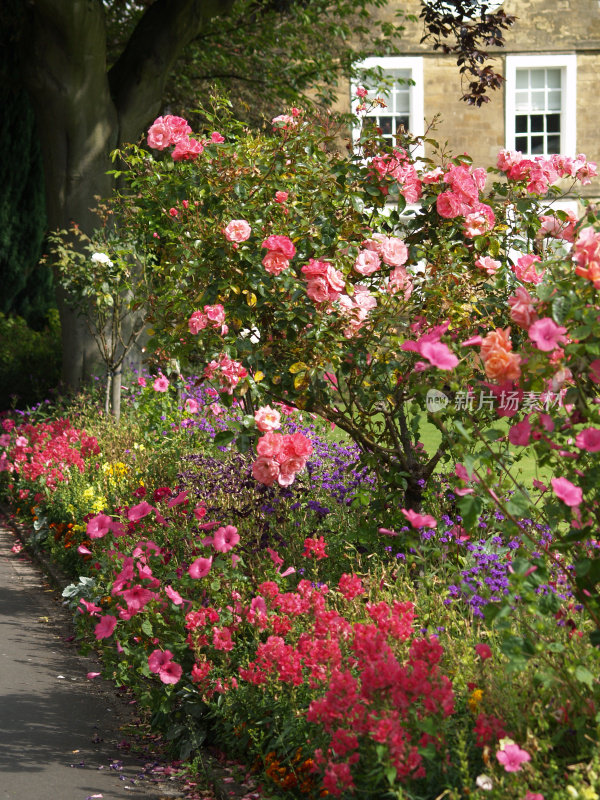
[504,54,577,158]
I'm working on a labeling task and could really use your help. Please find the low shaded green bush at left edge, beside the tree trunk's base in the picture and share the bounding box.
[0,311,61,410]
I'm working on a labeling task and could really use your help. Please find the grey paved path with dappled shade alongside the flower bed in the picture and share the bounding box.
[0,518,181,800]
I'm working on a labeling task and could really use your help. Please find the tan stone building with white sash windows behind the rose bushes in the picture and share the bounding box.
[344,0,600,197]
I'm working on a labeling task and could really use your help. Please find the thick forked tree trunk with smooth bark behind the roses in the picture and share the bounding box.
[21,0,233,388]
